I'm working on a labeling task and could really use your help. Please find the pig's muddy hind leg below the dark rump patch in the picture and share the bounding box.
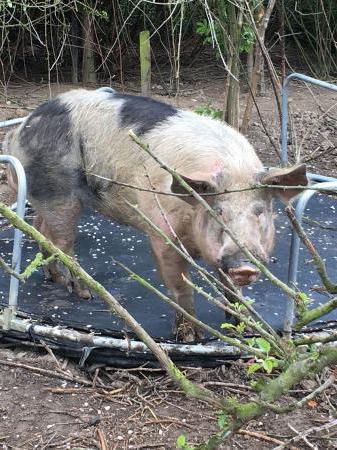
[34,199,91,298]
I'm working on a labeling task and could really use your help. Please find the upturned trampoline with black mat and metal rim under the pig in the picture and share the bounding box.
[0,74,337,366]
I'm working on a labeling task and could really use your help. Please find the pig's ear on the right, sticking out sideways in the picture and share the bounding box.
[260,164,309,203]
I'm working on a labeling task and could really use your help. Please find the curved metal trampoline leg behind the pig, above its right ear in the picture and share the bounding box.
[280,73,337,165]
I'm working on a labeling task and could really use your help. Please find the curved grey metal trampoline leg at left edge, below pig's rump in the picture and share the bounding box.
[0,155,27,311]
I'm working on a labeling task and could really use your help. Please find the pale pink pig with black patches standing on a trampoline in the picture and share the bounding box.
[4,89,308,342]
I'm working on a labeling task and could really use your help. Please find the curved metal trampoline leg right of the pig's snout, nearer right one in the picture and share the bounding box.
[283,181,337,335]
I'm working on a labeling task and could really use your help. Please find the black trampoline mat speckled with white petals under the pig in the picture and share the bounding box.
[0,195,337,340]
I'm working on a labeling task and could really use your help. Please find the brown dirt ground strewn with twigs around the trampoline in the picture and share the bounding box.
[0,67,337,450]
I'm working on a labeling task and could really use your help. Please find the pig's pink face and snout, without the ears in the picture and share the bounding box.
[192,194,274,286]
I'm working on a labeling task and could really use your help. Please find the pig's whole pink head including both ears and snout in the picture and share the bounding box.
[171,165,308,286]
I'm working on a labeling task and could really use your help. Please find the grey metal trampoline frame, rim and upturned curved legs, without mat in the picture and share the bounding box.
[0,73,337,358]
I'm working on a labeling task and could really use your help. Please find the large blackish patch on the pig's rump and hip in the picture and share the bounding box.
[20,99,82,200]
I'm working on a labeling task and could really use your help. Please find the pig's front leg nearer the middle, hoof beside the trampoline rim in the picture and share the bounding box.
[150,237,202,342]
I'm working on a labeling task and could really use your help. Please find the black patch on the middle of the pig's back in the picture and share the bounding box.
[111,93,178,136]
